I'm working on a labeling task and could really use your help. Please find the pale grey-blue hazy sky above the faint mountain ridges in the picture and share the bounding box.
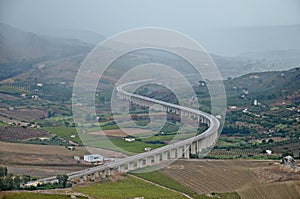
[0,0,300,36]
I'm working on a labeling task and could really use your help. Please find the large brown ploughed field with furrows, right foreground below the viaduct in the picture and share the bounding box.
[162,160,300,199]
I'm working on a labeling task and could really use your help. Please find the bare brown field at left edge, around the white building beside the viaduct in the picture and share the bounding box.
[0,142,124,177]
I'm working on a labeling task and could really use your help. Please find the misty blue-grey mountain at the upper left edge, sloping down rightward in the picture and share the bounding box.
[0,23,94,81]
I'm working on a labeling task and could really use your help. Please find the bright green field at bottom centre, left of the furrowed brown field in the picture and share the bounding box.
[74,176,186,199]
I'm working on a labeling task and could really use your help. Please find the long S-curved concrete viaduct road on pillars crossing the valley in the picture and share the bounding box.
[25,80,220,186]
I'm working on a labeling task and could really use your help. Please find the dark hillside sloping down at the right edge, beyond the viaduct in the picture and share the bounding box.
[224,68,300,104]
